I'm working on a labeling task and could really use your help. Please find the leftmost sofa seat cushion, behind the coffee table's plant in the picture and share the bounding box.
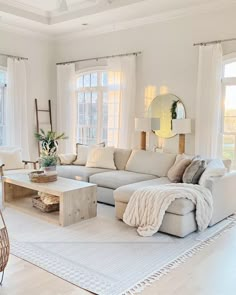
[57,165,110,182]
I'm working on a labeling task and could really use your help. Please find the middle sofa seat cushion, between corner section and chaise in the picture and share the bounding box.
[89,170,156,189]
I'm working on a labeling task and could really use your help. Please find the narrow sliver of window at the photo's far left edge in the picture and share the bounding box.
[0,67,7,146]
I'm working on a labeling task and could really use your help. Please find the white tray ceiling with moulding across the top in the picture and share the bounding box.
[0,0,236,39]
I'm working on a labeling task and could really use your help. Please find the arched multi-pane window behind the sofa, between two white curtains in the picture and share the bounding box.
[76,70,120,146]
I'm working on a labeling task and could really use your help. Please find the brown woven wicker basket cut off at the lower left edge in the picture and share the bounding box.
[0,210,10,285]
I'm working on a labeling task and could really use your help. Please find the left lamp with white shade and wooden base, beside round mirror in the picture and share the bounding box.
[135,118,160,150]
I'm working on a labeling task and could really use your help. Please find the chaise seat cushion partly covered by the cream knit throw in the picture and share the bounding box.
[113,177,195,215]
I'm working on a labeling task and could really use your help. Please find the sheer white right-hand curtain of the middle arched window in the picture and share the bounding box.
[108,55,136,148]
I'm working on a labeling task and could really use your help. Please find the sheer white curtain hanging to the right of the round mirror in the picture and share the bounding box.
[195,44,222,158]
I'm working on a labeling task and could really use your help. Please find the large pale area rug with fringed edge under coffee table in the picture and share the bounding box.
[4,205,235,295]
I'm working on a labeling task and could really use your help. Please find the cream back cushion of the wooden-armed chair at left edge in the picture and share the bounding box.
[0,148,24,170]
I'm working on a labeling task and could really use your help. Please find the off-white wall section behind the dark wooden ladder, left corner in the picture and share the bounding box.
[0,29,55,159]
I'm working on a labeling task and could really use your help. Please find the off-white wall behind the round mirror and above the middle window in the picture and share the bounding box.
[56,6,236,153]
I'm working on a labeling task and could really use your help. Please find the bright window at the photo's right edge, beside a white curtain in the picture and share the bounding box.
[222,58,236,169]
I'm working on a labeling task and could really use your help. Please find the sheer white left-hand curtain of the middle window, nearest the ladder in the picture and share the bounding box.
[57,64,76,153]
